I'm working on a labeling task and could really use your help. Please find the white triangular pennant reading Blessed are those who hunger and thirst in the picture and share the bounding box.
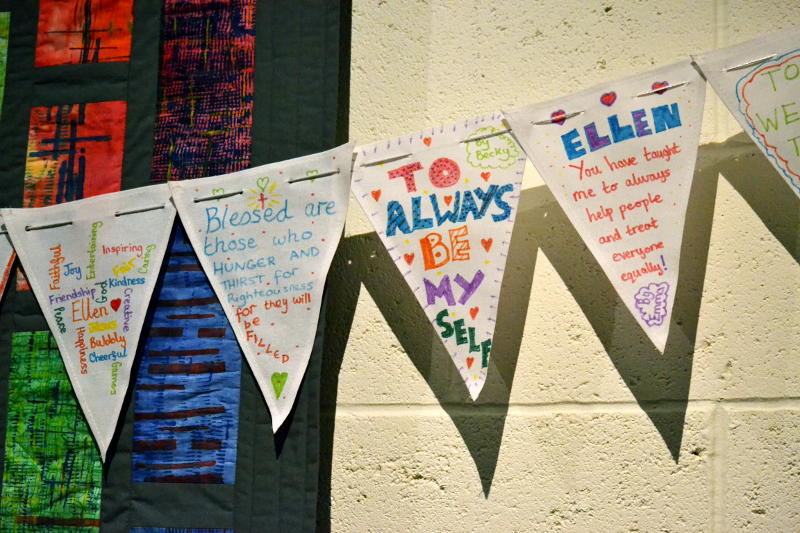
[170,145,353,431]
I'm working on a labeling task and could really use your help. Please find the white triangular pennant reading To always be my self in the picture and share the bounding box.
[353,113,525,400]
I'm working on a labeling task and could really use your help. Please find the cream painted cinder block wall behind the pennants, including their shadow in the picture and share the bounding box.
[323,0,800,533]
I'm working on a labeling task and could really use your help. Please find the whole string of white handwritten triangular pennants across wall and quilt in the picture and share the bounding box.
[0,29,800,459]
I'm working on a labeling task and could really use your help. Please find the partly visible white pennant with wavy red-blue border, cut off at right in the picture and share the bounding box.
[693,27,800,196]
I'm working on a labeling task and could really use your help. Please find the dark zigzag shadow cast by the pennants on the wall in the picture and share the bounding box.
[318,134,800,530]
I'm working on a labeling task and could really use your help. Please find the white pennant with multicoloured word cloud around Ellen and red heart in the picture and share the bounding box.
[2,185,175,460]
